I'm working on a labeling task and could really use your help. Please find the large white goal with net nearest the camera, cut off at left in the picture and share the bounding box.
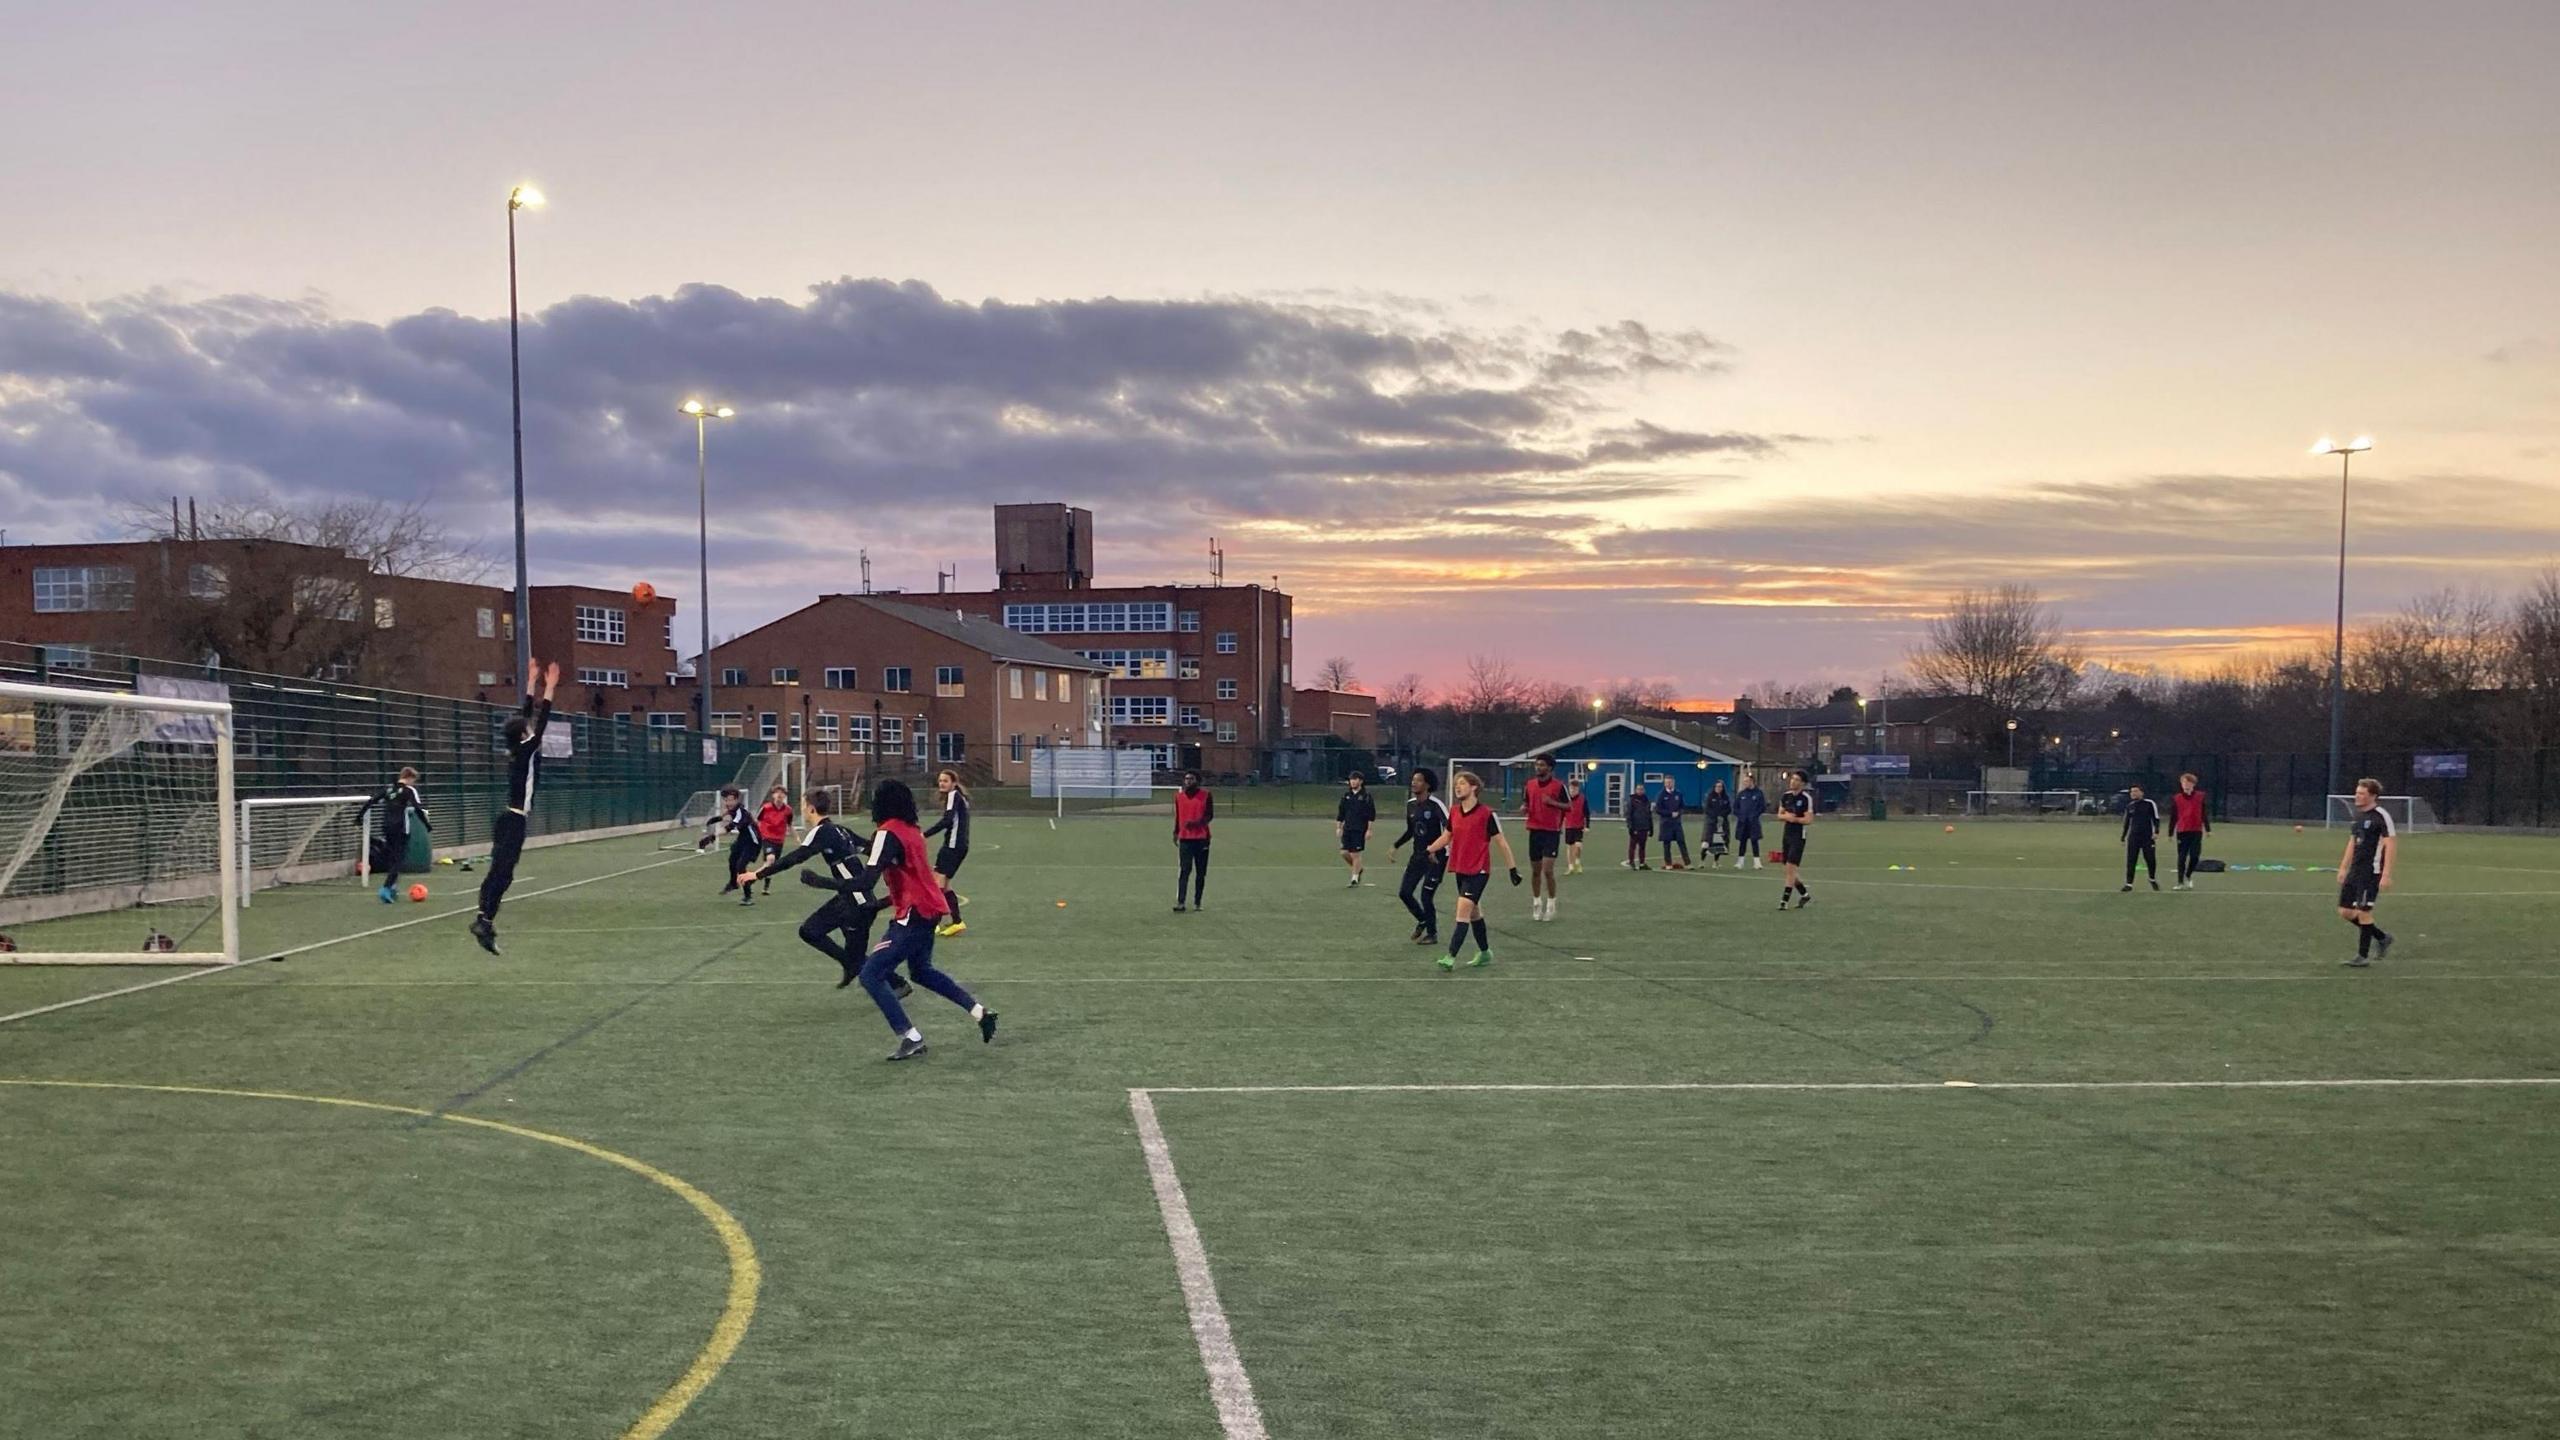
[0,682,241,966]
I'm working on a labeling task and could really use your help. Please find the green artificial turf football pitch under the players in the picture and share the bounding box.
[0,817,2560,1440]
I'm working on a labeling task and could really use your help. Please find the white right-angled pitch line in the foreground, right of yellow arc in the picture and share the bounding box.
[1129,1076,2560,1440]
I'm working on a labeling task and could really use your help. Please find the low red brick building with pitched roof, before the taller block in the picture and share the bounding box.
[678,594,1114,784]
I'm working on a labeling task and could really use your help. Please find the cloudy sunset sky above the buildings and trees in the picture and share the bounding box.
[0,0,2560,694]
